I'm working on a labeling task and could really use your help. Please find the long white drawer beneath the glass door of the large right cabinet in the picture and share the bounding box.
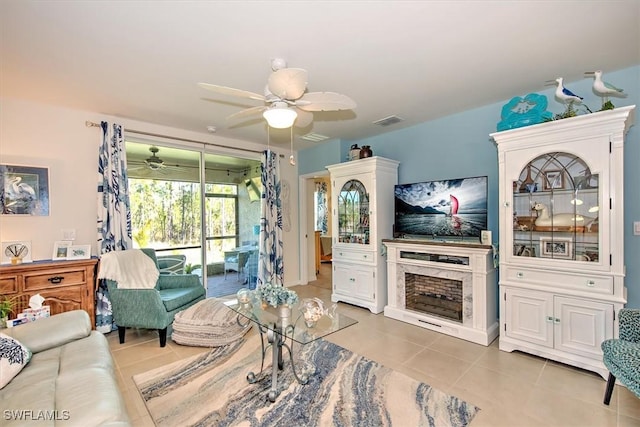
[506,267,613,294]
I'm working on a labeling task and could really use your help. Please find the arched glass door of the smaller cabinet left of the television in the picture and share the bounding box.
[338,179,370,245]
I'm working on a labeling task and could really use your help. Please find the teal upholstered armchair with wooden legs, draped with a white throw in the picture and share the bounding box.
[106,249,206,347]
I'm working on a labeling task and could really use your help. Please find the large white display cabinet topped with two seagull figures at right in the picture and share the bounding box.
[491,106,635,378]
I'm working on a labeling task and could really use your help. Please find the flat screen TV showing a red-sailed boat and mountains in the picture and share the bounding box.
[393,176,487,240]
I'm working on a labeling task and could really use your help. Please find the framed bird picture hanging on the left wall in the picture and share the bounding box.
[0,164,49,216]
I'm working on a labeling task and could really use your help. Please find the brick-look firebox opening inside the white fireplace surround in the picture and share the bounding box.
[404,273,462,322]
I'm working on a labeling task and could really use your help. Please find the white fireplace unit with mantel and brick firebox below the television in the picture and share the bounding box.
[383,239,499,345]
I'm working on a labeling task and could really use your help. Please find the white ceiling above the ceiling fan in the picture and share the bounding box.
[0,0,640,151]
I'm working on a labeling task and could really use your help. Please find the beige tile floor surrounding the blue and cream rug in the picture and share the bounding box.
[108,264,640,427]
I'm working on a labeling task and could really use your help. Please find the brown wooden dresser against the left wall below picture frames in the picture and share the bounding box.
[0,258,98,328]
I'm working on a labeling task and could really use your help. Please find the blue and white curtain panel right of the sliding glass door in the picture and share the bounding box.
[258,150,284,286]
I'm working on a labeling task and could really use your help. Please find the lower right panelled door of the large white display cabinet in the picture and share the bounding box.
[554,296,614,358]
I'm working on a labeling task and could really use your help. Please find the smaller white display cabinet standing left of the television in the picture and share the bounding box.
[327,157,399,313]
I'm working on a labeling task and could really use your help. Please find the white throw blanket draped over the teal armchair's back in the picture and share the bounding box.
[98,249,160,289]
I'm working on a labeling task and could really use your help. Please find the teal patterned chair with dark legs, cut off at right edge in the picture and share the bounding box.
[601,308,640,405]
